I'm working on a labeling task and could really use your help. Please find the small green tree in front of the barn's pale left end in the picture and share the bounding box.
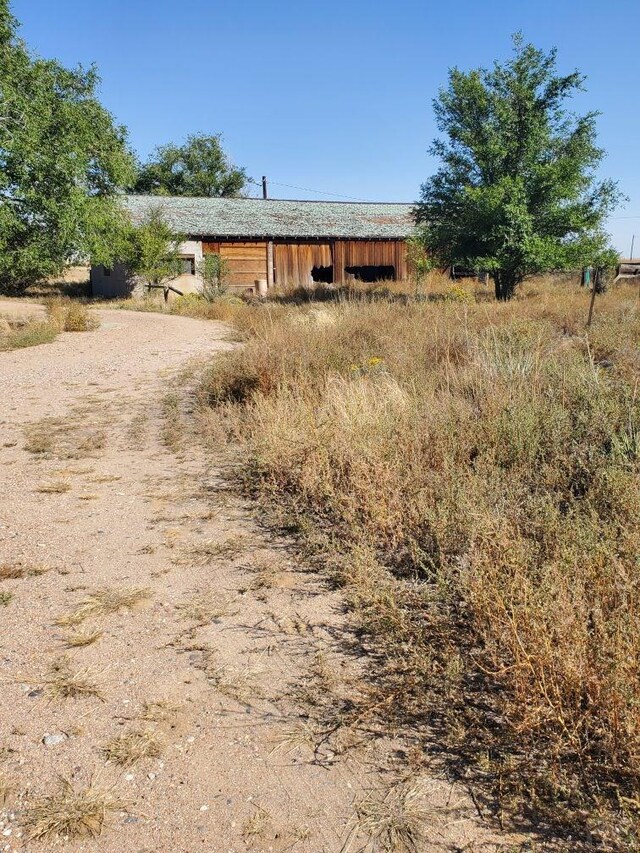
[123,205,183,300]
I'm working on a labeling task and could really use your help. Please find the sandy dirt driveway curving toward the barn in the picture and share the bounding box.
[0,302,518,853]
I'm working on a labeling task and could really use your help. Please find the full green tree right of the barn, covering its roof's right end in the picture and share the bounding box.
[416,34,618,299]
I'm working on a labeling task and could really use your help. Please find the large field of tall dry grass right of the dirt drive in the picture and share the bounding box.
[200,280,640,847]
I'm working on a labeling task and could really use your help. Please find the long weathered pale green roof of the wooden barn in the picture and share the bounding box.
[124,195,413,240]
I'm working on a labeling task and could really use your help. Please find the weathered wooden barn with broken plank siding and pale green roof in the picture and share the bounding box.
[91,195,413,297]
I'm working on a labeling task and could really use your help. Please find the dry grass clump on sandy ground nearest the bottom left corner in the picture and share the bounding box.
[24,778,126,841]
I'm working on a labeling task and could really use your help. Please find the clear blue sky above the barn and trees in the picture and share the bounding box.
[12,0,640,254]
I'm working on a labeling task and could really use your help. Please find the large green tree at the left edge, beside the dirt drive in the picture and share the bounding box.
[0,0,133,292]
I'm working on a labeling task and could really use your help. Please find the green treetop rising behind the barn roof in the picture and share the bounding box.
[133,134,248,197]
